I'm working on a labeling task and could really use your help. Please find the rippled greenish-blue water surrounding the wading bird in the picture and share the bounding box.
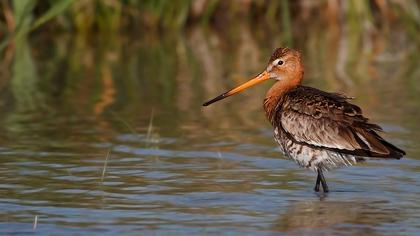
[0,26,420,235]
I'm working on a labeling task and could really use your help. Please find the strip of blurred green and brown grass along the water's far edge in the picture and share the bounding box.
[0,0,420,37]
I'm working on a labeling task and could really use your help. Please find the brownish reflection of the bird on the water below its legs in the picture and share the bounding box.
[273,200,404,235]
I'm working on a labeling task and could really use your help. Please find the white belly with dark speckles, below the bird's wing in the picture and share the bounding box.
[274,128,364,171]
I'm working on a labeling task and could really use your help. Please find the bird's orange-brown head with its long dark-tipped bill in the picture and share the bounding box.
[203,48,303,106]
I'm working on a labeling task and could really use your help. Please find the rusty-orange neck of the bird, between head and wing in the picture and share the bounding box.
[264,73,303,124]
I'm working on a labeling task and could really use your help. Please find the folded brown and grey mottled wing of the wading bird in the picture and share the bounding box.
[276,86,399,156]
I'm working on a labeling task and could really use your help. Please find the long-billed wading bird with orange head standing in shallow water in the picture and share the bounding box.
[203,48,405,192]
